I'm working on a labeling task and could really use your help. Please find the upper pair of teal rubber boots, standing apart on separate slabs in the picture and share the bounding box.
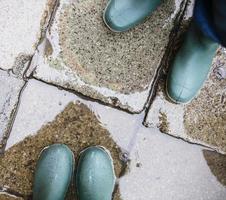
[103,0,218,103]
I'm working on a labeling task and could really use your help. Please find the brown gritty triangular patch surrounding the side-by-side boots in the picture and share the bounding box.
[0,103,124,200]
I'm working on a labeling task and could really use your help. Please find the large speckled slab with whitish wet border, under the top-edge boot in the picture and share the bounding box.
[32,0,185,113]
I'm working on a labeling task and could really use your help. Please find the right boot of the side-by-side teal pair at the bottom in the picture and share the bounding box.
[76,147,115,200]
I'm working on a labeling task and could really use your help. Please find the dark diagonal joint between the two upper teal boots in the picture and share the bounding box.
[143,0,190,127]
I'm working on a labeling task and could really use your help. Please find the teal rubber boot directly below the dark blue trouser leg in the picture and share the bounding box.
[166,24,219,103]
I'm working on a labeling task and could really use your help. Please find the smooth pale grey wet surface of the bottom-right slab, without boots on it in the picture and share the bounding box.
[120,128,226,200]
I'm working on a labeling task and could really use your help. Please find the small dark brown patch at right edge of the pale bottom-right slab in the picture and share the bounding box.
[203,150,226,186]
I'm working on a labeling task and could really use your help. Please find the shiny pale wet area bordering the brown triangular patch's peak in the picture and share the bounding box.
[6,79,138,150]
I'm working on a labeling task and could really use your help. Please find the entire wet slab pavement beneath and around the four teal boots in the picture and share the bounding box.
[0,0,226,200]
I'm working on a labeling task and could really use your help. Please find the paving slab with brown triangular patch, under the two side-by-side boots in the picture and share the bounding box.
[3,80,133,200]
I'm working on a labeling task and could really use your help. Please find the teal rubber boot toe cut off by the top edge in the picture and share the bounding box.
[103,0,163,32]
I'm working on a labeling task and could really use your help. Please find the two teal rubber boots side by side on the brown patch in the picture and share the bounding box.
[33,144,116,200]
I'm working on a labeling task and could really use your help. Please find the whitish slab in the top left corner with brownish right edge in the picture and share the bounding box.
[0,0,55,69]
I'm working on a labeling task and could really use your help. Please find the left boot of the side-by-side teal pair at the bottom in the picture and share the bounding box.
[33,144,74,200]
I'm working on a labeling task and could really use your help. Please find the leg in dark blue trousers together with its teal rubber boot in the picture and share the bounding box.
[166,0,221,103]
